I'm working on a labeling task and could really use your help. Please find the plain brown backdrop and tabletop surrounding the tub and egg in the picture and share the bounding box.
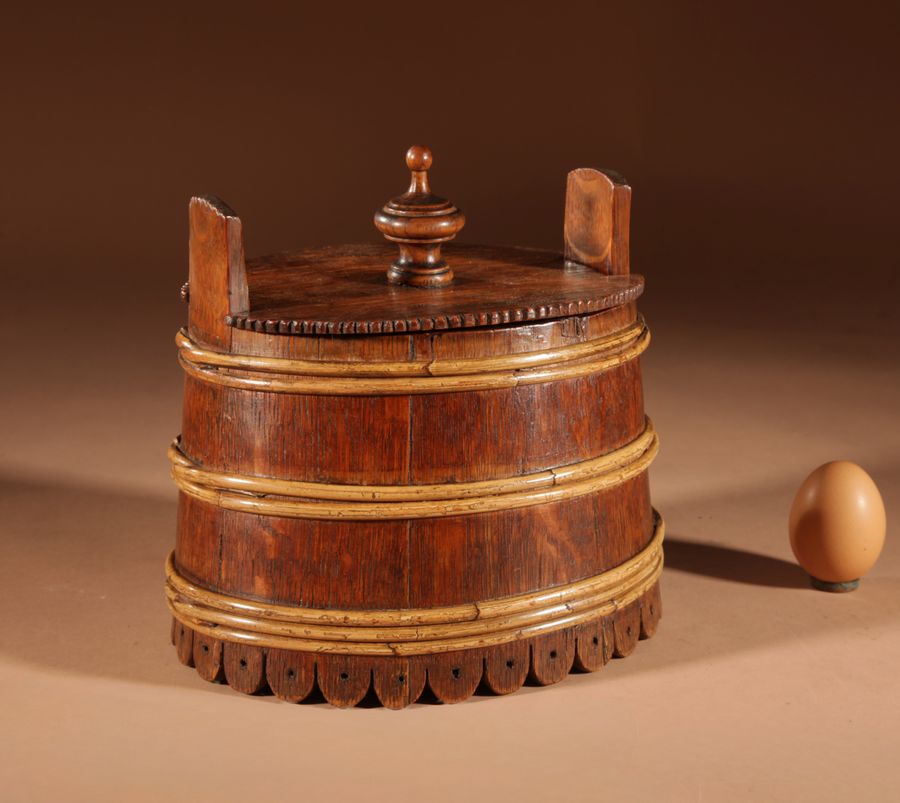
[0,3,900,800]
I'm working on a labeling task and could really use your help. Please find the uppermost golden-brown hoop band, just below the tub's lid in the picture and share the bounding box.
[175,319,650,396]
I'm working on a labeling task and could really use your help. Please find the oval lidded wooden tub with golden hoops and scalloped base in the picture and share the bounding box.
[166,149,663,708]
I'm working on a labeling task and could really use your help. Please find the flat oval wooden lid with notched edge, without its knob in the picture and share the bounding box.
[229,244,644,335]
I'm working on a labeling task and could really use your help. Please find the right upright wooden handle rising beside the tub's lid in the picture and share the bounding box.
[563,167,631,276]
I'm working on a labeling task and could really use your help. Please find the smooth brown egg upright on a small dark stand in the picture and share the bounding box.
[788,460,886,591]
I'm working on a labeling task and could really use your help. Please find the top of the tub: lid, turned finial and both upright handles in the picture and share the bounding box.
[187,146,644,340]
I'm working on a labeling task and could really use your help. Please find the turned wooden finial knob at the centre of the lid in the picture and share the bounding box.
[375,145,466,287]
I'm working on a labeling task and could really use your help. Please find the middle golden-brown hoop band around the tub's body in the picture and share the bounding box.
[169,418,659,521]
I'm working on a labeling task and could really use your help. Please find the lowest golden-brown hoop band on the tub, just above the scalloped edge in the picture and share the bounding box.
[166,511,665,655]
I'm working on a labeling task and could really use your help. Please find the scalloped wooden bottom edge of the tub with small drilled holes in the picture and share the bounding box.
[172,583,662,708]
